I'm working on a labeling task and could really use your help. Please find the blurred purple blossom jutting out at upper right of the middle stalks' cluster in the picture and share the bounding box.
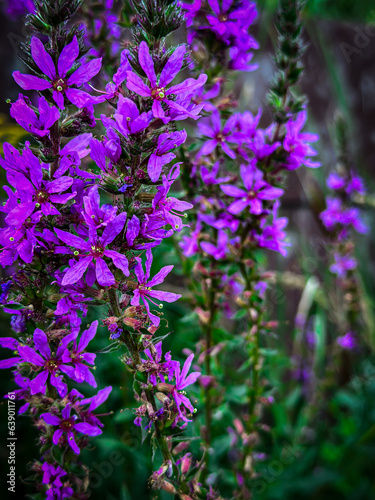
[283,111,320,170]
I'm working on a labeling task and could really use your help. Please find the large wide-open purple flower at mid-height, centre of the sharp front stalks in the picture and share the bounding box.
[55,212,129,286]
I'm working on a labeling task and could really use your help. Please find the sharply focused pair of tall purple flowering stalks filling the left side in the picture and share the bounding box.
[0,0,206,499]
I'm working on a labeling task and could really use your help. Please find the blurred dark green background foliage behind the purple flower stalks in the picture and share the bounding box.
[0,0,375,500]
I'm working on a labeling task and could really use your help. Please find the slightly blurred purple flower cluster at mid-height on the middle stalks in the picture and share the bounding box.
[181,108,320,268]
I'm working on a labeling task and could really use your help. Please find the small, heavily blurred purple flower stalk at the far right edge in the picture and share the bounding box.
[320,117,368,383]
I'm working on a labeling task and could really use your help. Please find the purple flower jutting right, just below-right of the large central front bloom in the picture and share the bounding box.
[130,249,181,326]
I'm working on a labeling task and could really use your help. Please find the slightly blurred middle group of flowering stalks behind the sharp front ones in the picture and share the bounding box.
[180,0,319,498]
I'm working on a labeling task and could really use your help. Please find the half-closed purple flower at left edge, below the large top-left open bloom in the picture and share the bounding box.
[10,94,60,137]
